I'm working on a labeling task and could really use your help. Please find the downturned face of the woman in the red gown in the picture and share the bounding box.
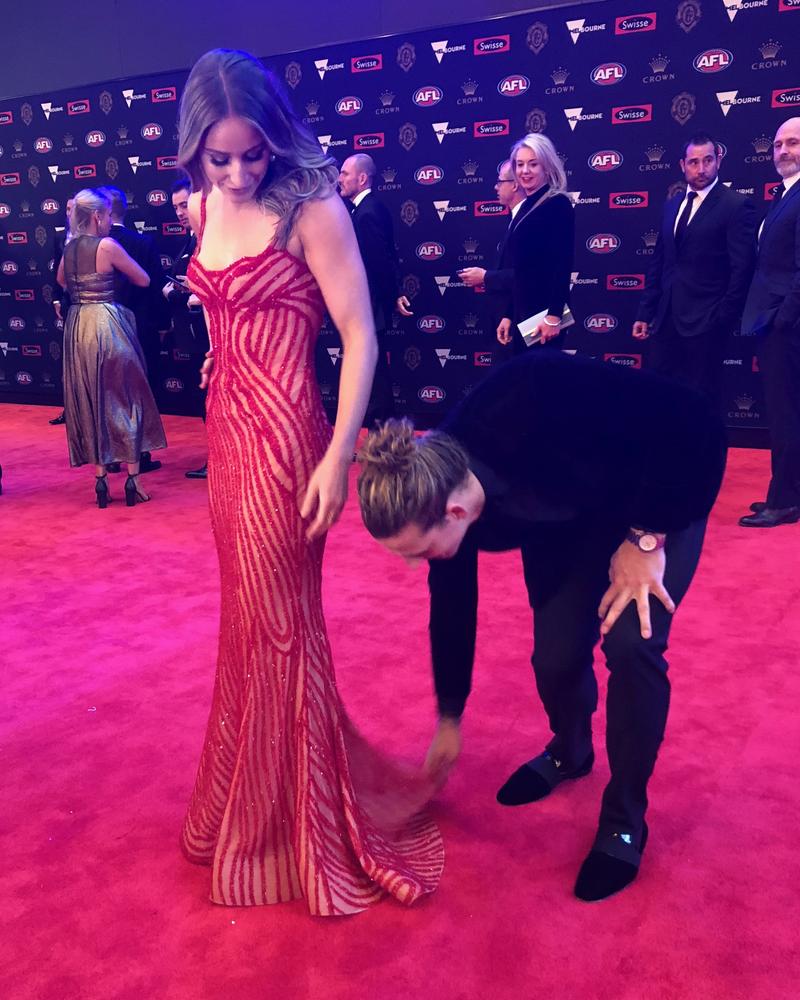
[200,117,270,203]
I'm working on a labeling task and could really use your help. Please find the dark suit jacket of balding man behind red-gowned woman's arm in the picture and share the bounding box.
[352,191,400,330]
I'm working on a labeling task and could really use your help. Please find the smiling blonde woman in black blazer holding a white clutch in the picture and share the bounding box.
[497,133,575,352]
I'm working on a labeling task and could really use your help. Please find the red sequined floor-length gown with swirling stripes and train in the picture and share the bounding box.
[181,203,444,915]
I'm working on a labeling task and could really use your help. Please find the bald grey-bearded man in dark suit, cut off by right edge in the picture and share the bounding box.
[739,118,800,528]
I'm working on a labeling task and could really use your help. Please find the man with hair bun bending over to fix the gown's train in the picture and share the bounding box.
[358,350,726,900]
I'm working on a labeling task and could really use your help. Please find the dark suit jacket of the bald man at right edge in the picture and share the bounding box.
[742,181,800,336]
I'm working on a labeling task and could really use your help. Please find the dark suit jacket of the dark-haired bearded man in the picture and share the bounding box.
[636,181,756,337]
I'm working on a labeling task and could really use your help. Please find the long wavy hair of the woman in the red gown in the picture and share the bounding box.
[178,49,339,245]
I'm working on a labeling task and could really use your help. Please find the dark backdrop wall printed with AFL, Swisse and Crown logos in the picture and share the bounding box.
[0,0,800,427]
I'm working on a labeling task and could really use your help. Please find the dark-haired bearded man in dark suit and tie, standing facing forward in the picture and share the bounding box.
[633,133,756,406]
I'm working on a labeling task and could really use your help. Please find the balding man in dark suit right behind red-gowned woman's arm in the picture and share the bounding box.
[339,153,412,424]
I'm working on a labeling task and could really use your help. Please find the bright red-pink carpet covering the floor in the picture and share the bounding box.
[0,405,800,1000]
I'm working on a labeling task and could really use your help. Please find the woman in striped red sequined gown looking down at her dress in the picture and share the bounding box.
[178,50,443,915]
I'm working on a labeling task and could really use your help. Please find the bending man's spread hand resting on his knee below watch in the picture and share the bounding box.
[598,542,675,639]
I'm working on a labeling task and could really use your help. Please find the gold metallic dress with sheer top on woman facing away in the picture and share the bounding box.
[64,236,167,466]
